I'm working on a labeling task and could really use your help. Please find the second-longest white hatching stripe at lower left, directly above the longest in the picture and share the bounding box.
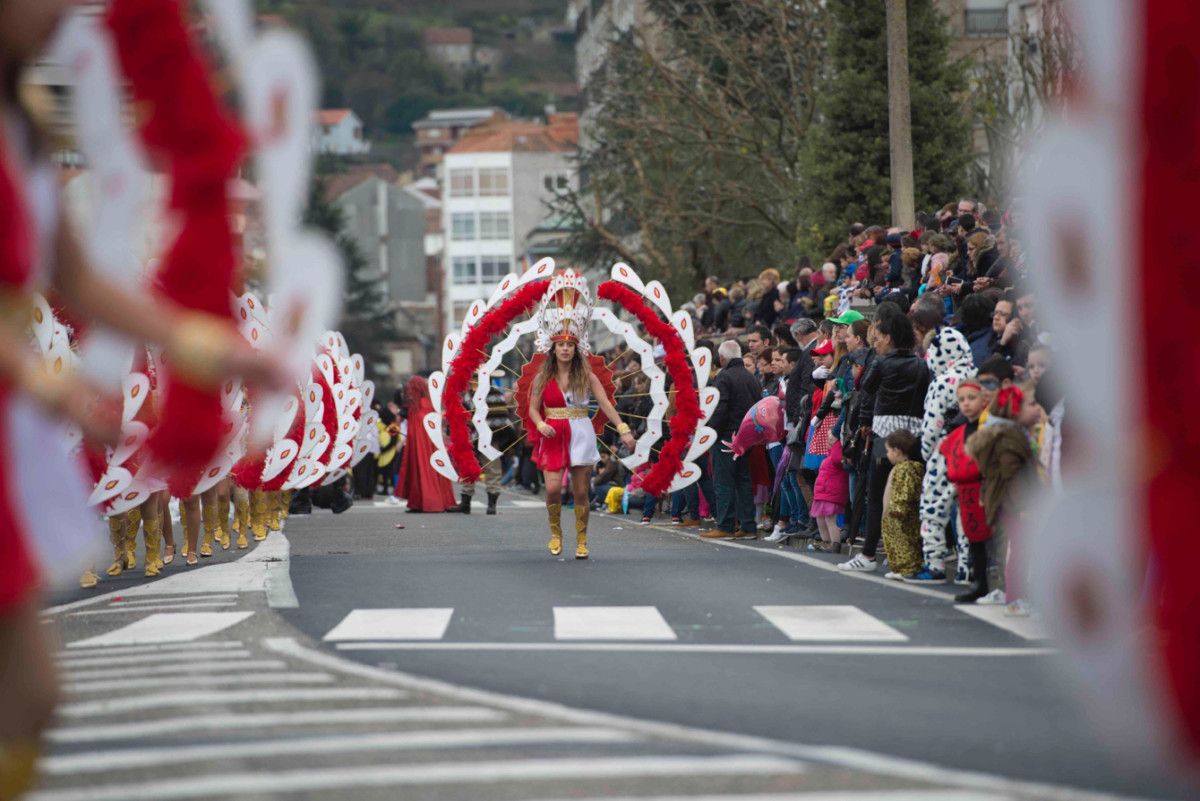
[38,727,641,776]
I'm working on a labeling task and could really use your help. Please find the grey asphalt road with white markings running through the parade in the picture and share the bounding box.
[42,494,1194,801]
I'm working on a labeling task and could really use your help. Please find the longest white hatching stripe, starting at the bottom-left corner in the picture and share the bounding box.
[30,755,804,801]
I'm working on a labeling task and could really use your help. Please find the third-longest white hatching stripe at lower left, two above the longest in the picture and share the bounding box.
[47,706,509,742]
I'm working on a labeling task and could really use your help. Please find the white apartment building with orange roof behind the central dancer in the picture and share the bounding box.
[442,114,578,331]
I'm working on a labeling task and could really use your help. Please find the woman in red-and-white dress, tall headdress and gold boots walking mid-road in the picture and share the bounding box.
[528,272,635,559]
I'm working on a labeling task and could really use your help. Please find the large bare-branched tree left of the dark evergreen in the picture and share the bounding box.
[559,0,827,297]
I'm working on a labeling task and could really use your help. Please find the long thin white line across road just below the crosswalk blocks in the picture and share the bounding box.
[337,642,1056,657]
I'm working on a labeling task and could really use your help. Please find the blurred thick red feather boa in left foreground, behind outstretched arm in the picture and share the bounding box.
[107,0,246,489]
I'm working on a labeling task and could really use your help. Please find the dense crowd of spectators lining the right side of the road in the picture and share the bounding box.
[367,200,1064,614]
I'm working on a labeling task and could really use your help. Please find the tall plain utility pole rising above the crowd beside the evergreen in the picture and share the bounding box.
[884,0,917,230]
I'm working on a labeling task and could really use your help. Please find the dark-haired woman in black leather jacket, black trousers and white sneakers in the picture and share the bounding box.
[838,305,930,573]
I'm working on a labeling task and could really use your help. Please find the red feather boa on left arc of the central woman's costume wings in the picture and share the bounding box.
[444,281,550,483]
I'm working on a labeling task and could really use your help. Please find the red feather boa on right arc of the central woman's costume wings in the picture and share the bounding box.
[596,281,701,495]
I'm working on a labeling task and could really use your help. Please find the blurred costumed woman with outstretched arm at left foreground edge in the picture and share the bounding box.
[0,0,275,801]
